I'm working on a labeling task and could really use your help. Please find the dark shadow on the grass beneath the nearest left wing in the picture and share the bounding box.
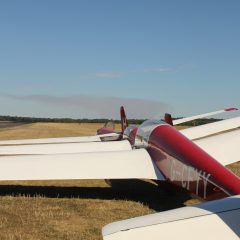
[0,180,191,212]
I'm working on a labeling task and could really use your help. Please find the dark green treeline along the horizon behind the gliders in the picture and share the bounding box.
[0,116,221,126]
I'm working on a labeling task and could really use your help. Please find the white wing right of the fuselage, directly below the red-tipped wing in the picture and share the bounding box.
[180,117,240,140]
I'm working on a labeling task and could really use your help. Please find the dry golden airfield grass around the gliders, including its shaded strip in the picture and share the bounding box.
[0,123,240,240]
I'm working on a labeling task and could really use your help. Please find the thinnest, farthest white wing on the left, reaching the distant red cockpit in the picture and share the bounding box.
[0,133,119,145]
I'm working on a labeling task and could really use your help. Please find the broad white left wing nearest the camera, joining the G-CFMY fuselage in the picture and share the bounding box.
[0,149,164,180]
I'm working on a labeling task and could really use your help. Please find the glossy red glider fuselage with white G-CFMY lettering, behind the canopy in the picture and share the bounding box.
[148,124,240,199]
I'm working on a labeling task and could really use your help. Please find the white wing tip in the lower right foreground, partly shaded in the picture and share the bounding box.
[102,195,240,240]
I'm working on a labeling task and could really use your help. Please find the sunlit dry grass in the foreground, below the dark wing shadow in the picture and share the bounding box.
[0,196,152,240]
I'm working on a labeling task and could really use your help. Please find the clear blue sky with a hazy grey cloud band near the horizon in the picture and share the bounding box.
[0,0,240,119]
